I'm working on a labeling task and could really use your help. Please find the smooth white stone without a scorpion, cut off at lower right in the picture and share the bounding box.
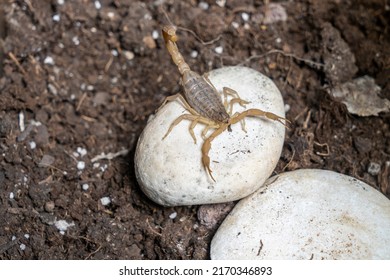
[210,169,390,260]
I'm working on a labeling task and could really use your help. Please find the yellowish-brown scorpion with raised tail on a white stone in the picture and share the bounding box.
[160,25,289,182]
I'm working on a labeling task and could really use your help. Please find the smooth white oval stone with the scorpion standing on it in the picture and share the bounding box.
[135,67,285,206]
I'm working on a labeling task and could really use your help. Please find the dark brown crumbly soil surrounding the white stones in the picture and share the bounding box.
[0,0,390,259]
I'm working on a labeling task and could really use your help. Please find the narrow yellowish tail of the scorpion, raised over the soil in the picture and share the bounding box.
[162,25,190,75]
